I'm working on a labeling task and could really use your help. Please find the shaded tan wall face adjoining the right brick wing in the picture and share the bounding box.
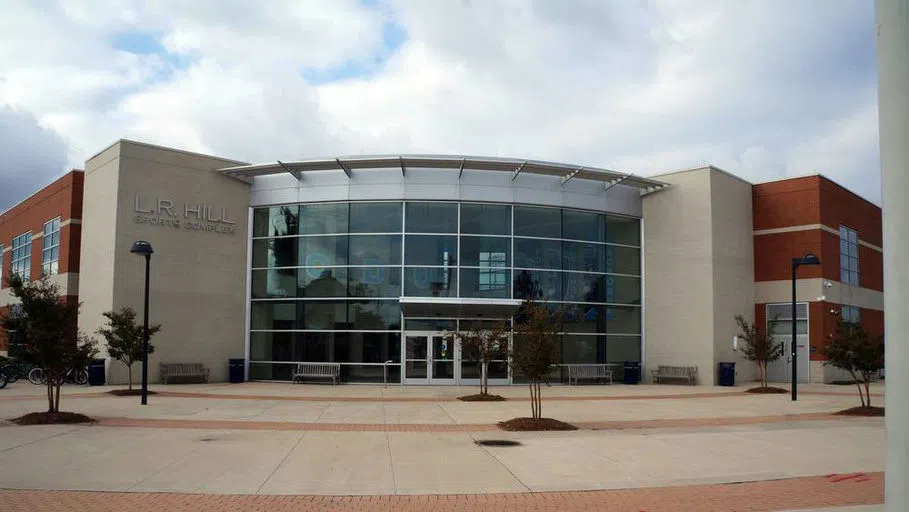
[710,171,757,382]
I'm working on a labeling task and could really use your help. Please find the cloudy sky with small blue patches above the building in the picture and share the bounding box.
[0,0,881,210]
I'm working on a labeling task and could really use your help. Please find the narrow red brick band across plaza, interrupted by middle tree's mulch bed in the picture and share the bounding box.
[85,413,847,432]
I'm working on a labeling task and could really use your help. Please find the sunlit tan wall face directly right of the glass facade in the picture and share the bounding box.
[643,172,714,384]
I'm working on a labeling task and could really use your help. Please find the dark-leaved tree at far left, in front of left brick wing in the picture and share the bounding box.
[0,274,97,413]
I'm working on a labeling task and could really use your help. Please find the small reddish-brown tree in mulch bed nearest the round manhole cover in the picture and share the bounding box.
[512,300,561,420]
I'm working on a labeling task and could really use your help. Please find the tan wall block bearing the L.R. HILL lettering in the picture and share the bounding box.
[80,141,249,383]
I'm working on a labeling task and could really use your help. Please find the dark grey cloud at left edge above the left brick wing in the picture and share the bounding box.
[0,106,67,212]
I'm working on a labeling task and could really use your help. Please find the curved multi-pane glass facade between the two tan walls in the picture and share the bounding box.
[250,201,642,382]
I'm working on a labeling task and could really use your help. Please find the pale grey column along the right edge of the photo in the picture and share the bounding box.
[877,0,909,512]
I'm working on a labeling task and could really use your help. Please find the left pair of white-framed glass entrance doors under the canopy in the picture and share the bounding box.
[404,332,460,384]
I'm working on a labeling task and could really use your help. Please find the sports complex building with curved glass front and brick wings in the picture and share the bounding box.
[0,140,882,384]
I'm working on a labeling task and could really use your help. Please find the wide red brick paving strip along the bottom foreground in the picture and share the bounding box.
[0,472,884,512]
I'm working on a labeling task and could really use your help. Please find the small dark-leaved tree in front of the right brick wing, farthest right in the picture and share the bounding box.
[824,319,884,407]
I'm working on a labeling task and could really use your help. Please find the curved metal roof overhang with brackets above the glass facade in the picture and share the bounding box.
[219,155,668,195]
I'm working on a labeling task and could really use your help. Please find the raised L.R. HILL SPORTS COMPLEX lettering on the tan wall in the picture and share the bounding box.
[133,192,237,235]
